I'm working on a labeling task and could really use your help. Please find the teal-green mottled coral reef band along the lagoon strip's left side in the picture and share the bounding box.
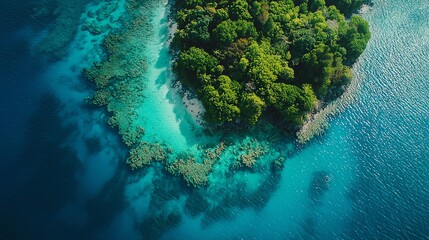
[83,0,153,151]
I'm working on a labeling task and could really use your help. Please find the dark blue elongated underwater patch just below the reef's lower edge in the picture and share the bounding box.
[132,162,281,239]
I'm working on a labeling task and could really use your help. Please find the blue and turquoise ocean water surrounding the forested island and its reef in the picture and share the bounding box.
[0,0,429,240]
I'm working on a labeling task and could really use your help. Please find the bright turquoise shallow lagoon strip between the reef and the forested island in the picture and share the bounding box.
[132,1,209,152]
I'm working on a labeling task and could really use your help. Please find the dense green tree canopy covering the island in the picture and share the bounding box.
[174,0,370,126]
